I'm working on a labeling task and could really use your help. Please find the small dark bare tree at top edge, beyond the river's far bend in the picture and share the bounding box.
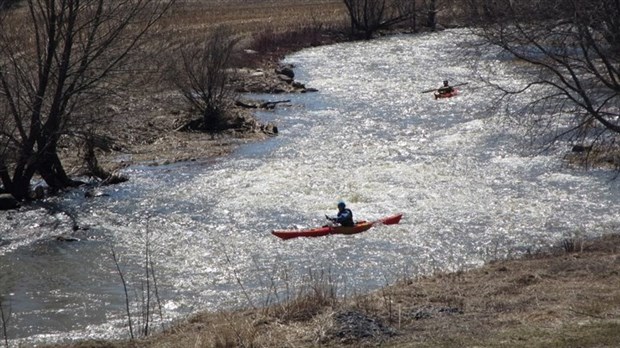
[344,0,415,40]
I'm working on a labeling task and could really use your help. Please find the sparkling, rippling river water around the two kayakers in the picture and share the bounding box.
[0,30,620,344]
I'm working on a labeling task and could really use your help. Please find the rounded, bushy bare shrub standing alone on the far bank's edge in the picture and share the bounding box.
[174,26,239,131]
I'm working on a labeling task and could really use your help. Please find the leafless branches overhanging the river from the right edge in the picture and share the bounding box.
[470,0,620,151]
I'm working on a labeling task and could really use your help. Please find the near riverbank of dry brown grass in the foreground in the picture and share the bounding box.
[52,235,620,348]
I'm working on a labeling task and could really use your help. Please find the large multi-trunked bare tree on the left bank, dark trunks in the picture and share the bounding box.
[0,0,174,199]
